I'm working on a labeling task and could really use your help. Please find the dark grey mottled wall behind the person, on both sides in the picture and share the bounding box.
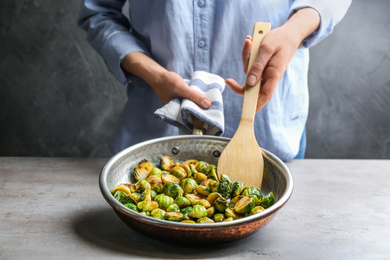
[0,0,390,159]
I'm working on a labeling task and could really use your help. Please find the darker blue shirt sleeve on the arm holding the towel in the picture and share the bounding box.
[77,0,149,84]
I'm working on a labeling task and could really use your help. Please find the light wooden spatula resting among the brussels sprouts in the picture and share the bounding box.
[217,23,271,189]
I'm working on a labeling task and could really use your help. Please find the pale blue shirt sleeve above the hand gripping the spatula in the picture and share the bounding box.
[289,0,352,48]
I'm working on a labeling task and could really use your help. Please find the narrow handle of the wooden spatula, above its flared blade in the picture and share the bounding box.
[240,22,271,124]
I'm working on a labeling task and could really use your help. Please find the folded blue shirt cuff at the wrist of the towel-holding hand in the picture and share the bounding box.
[100,31,150,84]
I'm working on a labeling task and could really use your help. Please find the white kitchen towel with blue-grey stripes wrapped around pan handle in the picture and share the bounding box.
[154,71,225,135]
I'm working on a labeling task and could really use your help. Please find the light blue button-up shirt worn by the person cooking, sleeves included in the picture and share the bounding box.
[78,0,351,161]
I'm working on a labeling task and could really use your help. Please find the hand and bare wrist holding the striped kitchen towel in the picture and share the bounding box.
[121,52,211,109]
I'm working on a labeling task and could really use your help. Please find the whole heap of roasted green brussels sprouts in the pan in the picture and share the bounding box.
[111,156,275,223]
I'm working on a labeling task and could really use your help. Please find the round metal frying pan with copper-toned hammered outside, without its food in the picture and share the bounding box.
[99,135,293,245]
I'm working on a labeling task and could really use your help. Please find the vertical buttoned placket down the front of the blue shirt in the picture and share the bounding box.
[194,0,210,71]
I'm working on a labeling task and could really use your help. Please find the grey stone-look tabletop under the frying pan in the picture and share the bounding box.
[0,157,390,259]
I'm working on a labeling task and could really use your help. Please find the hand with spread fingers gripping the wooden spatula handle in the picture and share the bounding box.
[226,8,320,112]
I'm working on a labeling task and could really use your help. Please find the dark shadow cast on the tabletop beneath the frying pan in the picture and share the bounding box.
[73,208,258,259]
